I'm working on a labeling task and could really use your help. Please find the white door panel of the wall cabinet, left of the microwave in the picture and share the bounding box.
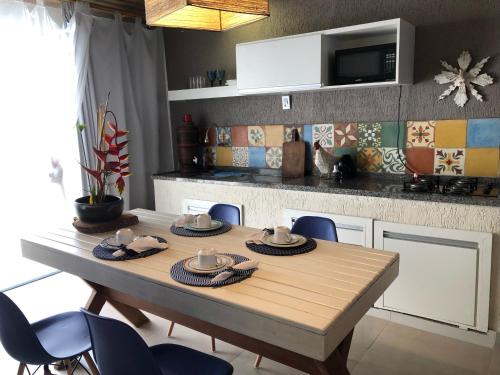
[236,34,321,92]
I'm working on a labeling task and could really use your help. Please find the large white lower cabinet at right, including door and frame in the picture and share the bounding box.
[374,221,492,332]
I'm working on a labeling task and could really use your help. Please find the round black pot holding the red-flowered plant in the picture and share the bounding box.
[75,195,123,223]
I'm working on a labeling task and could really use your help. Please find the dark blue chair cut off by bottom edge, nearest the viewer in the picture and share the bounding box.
[82,310,233,375]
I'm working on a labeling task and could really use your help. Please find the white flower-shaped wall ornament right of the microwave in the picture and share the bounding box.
[434,51,493,107]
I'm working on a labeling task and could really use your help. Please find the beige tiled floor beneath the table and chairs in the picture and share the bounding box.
[0,274,500,375]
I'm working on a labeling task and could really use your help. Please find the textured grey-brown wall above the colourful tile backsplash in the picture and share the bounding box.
[165,0,500,126]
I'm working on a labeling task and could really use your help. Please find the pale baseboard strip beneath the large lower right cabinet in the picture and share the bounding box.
[367,308,500,348]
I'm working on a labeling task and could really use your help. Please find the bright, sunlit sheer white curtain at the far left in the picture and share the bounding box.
[0,0,81,289]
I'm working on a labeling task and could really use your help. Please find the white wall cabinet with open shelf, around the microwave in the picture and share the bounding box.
[169,18,415,101]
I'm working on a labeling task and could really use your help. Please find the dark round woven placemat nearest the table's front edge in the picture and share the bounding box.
[170,254,255,287]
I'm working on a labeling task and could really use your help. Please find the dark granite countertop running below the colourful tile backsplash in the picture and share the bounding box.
[153,171,500,207]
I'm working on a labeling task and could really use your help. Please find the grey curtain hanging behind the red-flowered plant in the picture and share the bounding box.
[70,3,173,212]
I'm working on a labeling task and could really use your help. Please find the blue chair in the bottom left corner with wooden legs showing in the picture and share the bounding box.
[0,293,99,375]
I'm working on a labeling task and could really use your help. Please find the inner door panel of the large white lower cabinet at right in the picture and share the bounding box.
[383,234,477,326]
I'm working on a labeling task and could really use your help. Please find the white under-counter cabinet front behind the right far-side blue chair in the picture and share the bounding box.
[283,209,373,247]
